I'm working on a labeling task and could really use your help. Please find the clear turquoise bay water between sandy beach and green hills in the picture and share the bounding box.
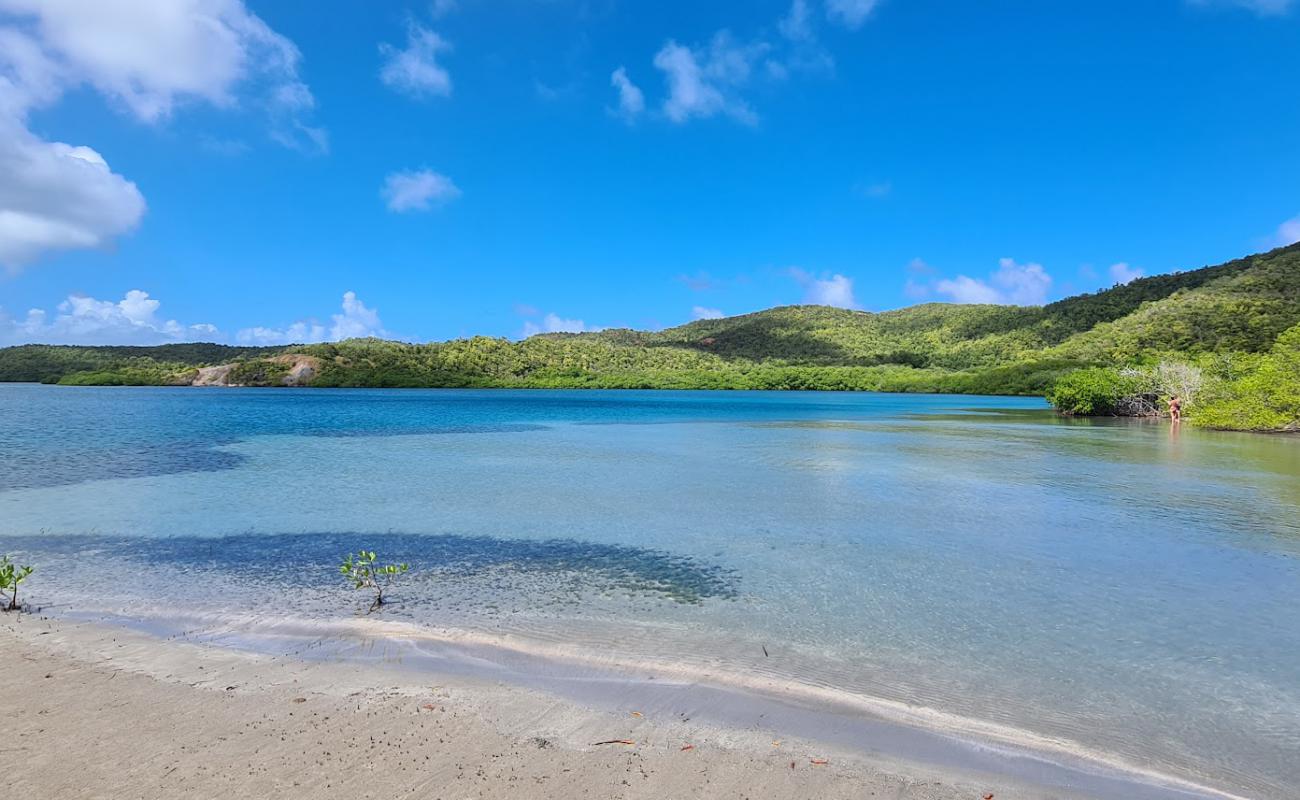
[0,385,1300,797]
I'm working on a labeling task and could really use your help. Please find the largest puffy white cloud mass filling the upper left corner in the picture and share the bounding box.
[0,0,325,271]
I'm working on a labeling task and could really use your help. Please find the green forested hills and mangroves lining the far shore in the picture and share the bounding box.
[0,245,1300,429]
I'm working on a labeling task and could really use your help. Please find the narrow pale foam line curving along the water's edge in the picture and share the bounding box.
[68,610,1249,800]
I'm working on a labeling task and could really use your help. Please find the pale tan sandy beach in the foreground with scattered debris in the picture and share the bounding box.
[0,614,1047,800]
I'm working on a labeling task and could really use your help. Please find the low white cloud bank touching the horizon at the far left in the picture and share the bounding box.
[0,289,220,345]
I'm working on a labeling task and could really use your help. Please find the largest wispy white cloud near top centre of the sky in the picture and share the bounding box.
[654,31,768,125]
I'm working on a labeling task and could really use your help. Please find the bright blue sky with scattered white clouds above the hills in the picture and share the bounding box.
[0,0,1300,345]
